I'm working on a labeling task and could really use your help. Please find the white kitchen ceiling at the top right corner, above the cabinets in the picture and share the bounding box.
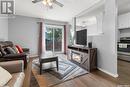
[117,0,130,15]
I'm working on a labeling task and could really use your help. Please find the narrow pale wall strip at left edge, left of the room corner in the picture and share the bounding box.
[0,18,8,41]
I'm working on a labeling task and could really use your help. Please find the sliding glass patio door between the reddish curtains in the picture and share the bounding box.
[45,25,64,52]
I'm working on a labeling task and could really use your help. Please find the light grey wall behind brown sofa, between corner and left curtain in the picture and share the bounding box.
[9,16,40,54]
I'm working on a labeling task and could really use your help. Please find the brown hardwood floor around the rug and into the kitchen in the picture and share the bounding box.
[24,57,130,87]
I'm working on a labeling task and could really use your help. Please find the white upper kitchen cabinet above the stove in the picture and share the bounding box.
[118,13,130,29]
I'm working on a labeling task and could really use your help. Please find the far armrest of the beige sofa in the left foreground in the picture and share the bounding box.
[0,60,24,74]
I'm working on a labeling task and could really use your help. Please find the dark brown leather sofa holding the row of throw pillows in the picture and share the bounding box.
[0,41,29,68]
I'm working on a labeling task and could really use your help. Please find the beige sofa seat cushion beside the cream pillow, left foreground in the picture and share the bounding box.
[5,72,25,87]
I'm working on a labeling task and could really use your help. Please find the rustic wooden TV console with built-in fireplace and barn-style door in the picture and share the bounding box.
[68,46,97,72]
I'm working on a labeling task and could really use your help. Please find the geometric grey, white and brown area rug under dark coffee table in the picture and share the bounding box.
[33,56,88,87]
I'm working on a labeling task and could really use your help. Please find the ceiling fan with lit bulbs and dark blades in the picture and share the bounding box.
[32,0,64,7]
